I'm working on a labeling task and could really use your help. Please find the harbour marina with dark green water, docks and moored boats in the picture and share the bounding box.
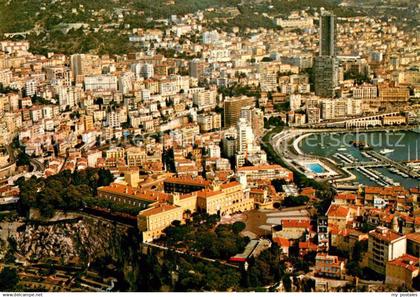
[299,131,420,188]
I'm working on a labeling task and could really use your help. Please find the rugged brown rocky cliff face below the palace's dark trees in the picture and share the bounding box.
[15,214,140,290]
